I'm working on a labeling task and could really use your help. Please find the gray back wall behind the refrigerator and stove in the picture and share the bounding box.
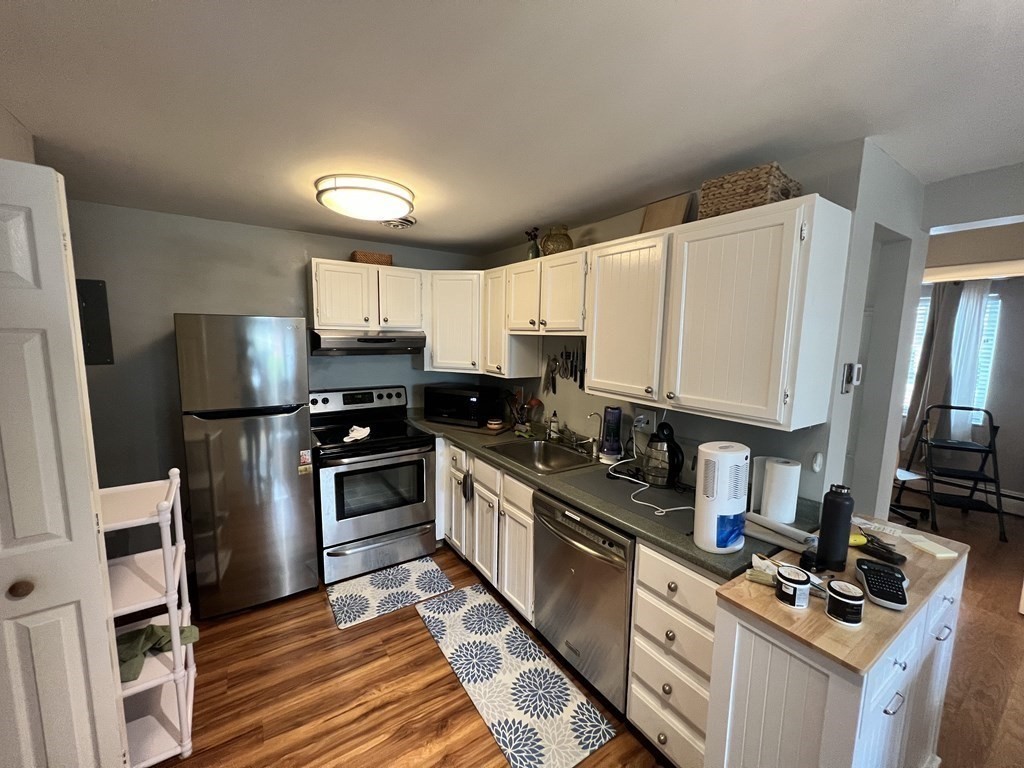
[69,201,475,486]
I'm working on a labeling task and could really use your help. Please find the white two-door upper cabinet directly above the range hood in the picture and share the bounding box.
[312,259,423,331]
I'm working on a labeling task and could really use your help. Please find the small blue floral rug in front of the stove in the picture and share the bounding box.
[327,556,453,630]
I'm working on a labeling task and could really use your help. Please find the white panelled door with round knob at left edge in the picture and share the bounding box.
[0,160,123,768]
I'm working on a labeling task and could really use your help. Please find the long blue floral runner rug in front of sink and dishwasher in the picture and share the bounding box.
[416,584,615,768]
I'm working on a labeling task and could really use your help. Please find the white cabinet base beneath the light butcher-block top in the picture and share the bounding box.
[706,559,966,768]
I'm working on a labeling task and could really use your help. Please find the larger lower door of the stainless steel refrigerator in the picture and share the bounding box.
[182,406,317,618]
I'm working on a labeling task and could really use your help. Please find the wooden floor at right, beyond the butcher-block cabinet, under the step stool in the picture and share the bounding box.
[905,509,1024,768]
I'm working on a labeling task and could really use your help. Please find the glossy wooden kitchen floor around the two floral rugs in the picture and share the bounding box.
[172,548,657,768]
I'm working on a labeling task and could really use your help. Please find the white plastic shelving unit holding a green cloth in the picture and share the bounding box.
[99,469,196,768]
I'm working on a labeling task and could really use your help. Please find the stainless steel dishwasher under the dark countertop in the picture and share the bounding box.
[534,492,636,712]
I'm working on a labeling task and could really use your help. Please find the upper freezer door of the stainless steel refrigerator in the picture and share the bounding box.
[174,314,309,414]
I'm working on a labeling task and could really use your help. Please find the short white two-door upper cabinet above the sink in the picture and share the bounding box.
[506,250,587,334]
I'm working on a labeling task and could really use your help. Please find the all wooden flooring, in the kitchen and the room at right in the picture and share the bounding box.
[164,511,1024,768]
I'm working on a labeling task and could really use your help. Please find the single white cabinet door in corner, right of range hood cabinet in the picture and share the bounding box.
[430,271,481,372]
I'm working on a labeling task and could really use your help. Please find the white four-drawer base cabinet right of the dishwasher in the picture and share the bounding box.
[626,542,718,768]
